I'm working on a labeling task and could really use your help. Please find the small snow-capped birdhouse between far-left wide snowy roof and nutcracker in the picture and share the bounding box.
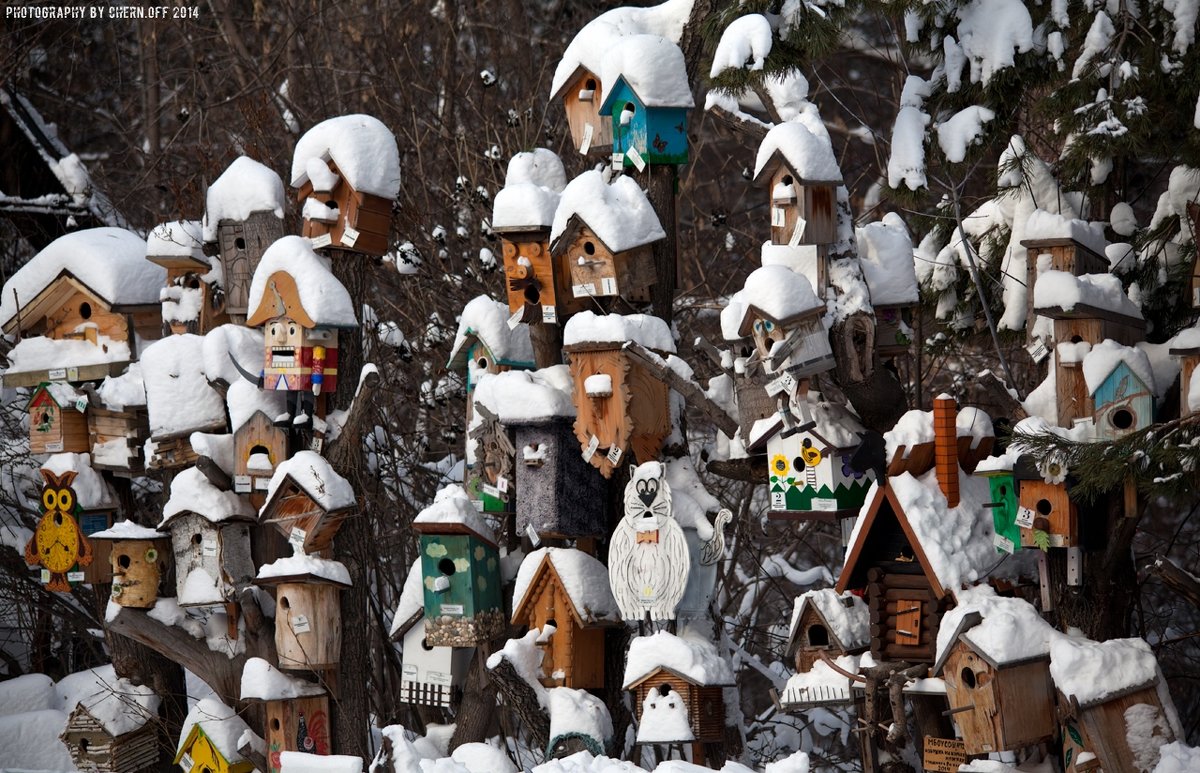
[146,220,226,335]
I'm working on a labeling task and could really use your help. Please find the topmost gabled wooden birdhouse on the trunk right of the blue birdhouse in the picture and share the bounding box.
[754,120,842,245]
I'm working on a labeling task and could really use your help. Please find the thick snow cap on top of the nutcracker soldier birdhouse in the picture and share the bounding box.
[247,235,359,328]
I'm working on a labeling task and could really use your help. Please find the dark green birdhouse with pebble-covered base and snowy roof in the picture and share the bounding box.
[413,486,506,647]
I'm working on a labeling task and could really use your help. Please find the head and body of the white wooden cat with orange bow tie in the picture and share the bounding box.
[608,462,691,621]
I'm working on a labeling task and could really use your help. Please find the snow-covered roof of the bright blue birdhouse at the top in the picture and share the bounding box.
[600,35,696,113]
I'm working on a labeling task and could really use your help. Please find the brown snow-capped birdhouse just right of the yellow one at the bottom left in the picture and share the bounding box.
[241,658,332,773]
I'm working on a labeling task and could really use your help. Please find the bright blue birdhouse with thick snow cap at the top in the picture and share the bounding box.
[600,35,696,170]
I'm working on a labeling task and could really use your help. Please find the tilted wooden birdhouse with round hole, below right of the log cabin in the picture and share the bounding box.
[932,588,1058,754]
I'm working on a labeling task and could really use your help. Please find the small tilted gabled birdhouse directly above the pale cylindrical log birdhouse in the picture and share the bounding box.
[258,451,358,553]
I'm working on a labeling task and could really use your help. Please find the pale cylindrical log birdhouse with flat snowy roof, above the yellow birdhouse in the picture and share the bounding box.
[254,551,350,671]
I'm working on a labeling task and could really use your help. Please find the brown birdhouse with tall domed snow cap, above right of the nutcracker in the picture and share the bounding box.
[292,115,400,256]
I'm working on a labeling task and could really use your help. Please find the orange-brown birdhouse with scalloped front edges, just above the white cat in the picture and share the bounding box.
[563,311,674,478]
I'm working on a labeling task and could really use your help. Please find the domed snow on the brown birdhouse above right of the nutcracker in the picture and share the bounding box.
[292,115,400,198]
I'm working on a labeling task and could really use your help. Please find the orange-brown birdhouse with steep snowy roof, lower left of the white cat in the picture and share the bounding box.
[512,547,620,689]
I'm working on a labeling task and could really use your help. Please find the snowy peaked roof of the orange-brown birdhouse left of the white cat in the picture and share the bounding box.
[512,547,620,627]
